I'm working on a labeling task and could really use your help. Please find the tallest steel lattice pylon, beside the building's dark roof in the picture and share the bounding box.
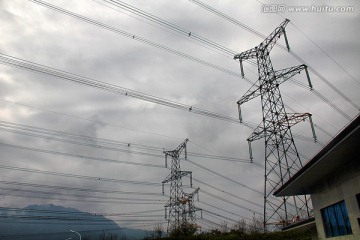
[234,19,316,230]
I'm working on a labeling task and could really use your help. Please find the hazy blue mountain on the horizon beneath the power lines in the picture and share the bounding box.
[0,204,147,240]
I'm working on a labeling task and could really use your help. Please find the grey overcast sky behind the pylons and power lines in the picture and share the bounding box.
[0,0,360,232]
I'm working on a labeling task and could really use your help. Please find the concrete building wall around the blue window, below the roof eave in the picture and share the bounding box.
[311,158,360,240]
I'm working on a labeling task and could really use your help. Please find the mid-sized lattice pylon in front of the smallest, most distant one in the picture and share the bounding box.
[162,139,192,232]
